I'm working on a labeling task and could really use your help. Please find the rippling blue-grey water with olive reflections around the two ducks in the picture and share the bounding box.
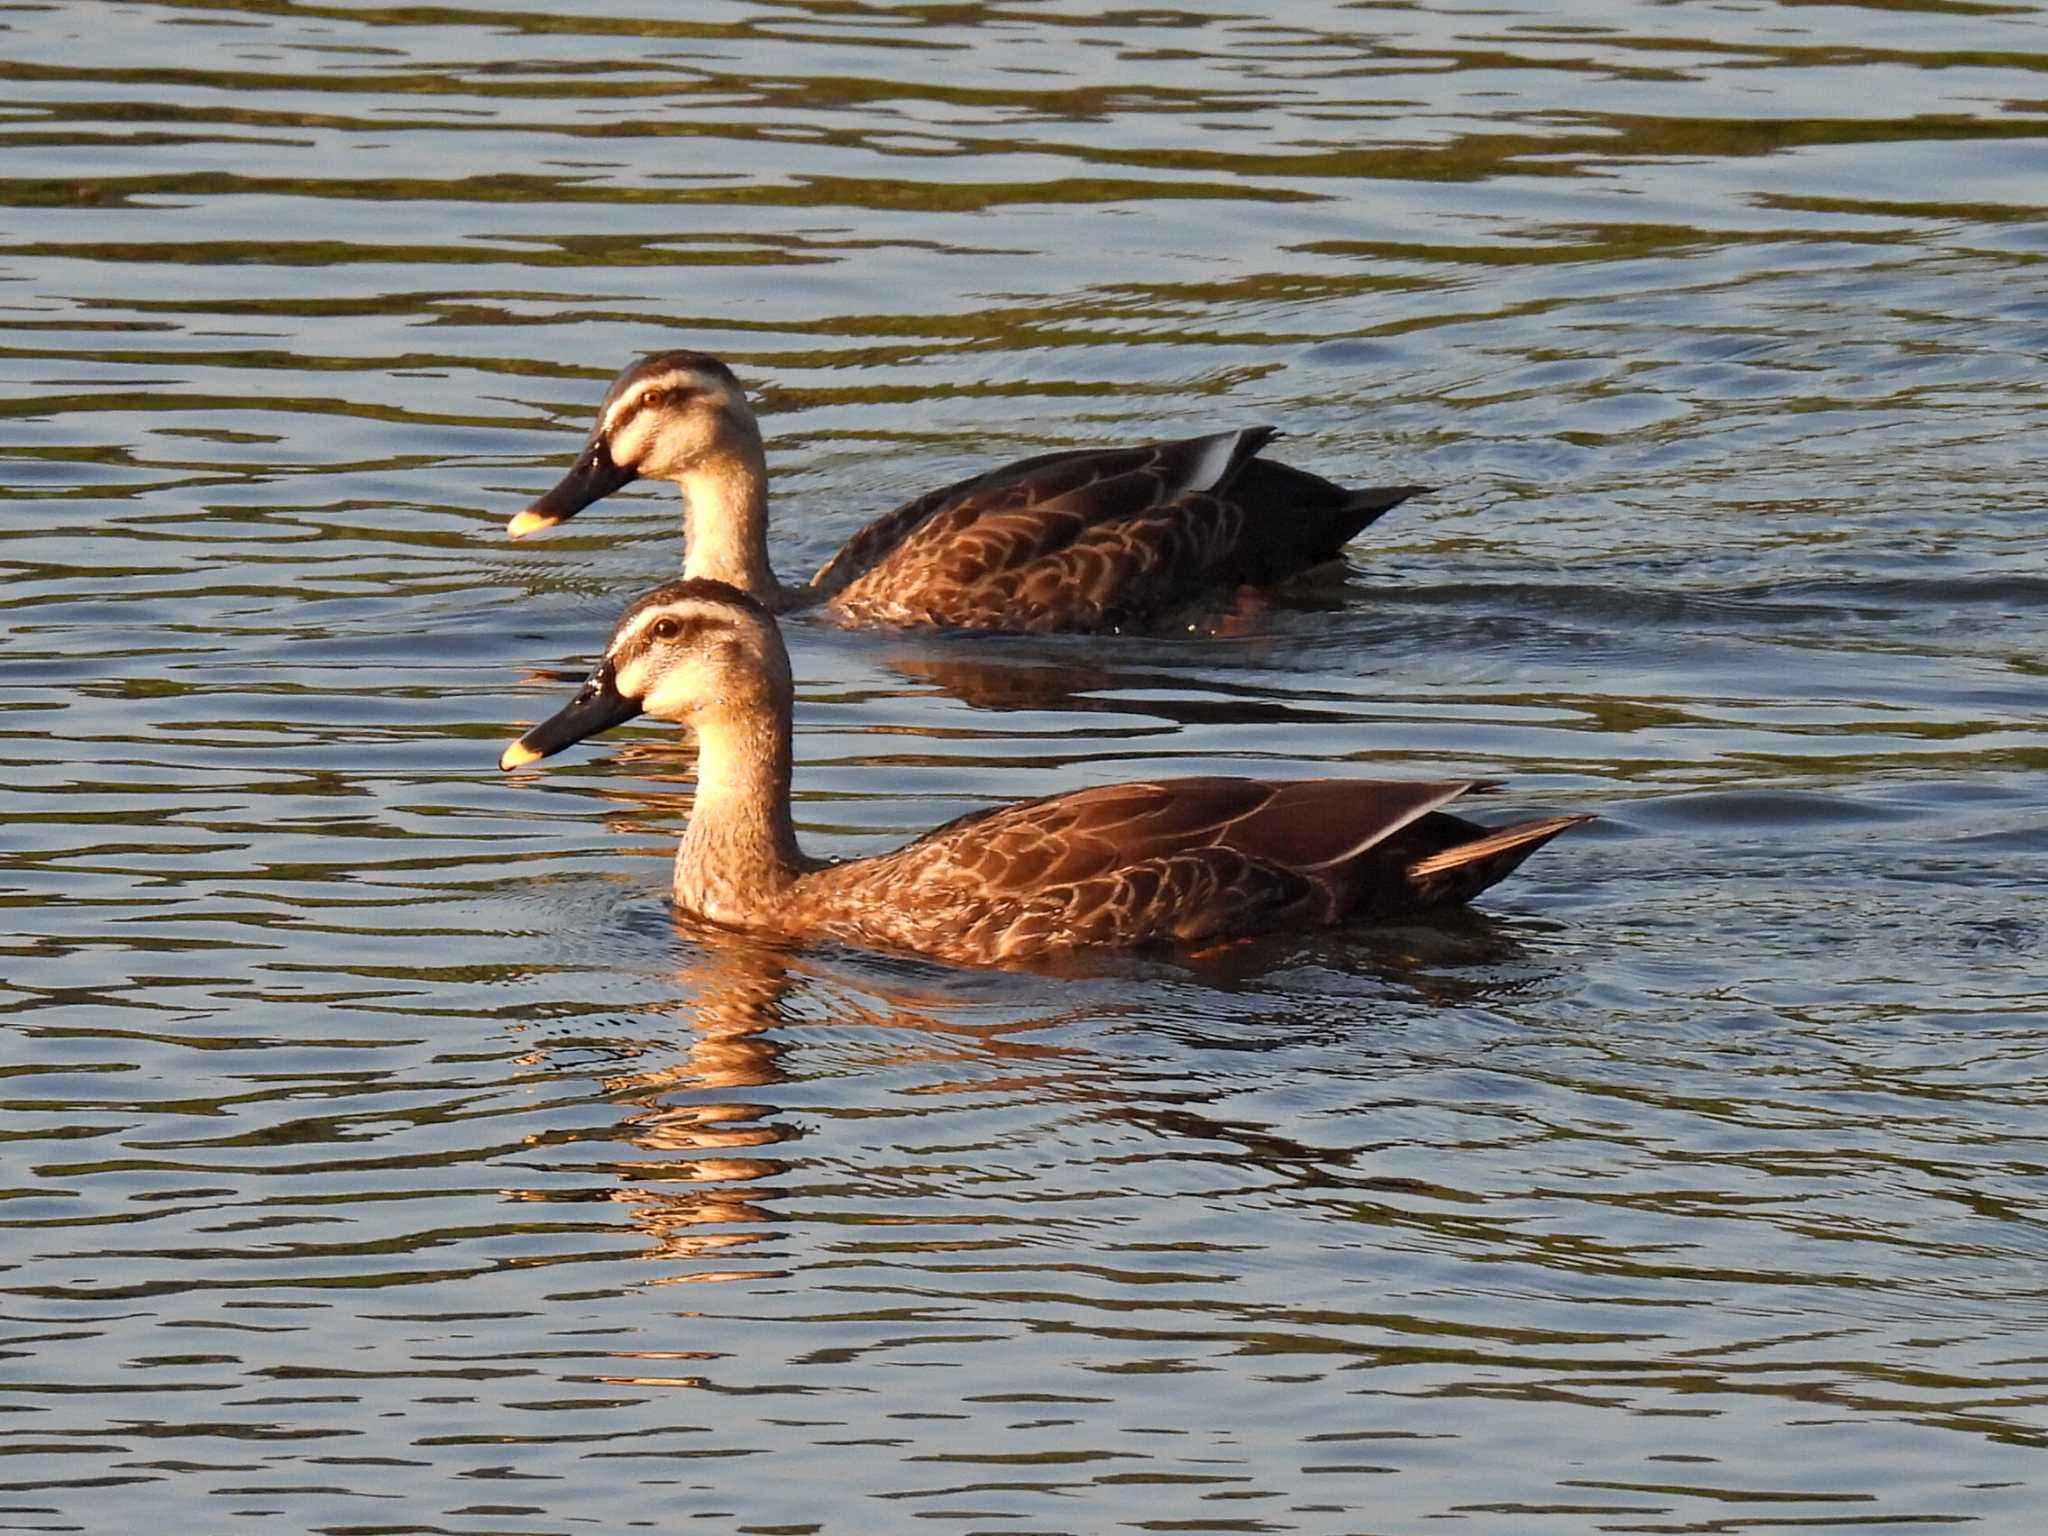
[0,0,2048,1534]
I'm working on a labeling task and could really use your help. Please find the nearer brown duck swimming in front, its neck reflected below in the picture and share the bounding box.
[498,578,1589,965]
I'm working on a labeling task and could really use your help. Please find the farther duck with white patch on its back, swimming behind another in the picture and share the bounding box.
[506,352,1430,633]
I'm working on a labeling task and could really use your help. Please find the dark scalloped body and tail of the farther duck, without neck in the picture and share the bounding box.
[811,426,1425,631]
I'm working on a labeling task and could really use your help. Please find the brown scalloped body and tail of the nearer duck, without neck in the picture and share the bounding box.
[819,778,1585,963]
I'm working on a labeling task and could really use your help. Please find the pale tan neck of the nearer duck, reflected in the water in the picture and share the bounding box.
[676,707,805,926]
